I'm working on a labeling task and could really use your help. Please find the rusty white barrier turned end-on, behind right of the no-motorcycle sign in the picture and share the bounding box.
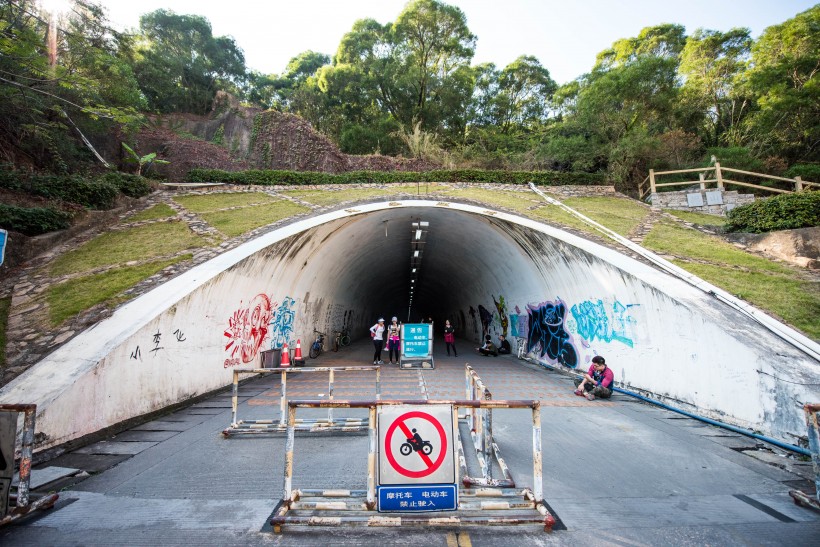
[458,365,515,488]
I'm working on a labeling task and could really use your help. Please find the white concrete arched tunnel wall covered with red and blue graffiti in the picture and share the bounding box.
[0,201,820,449]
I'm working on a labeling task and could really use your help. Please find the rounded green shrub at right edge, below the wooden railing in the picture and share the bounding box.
[726,190,820,233]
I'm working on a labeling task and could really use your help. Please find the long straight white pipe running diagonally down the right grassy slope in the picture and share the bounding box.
[529,182,820,361]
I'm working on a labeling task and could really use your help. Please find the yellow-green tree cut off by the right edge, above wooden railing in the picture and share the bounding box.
[743,5,820,163]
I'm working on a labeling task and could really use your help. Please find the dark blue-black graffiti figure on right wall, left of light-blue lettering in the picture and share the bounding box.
[527,300,578,368]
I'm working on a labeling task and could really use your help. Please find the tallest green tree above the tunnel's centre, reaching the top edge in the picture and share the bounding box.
[330,0,475,144]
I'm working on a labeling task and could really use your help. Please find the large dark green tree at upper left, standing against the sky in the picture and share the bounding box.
[133,9,245,113]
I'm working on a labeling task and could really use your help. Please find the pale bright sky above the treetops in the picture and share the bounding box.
[94,0,815,84]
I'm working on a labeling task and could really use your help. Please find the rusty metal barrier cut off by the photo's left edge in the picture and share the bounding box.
[0,404,60,526]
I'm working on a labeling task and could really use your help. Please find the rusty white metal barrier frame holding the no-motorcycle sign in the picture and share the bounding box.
[270,400,556,533]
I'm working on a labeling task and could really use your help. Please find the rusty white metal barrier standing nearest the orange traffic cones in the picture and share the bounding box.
[222,365,381,437]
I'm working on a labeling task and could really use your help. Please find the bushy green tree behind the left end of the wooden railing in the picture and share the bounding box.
[556,25,684,191]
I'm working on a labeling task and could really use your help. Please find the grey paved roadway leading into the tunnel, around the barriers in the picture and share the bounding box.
[0,340,820,547]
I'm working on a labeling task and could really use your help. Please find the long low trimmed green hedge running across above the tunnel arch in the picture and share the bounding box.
[188,169,604,186]
